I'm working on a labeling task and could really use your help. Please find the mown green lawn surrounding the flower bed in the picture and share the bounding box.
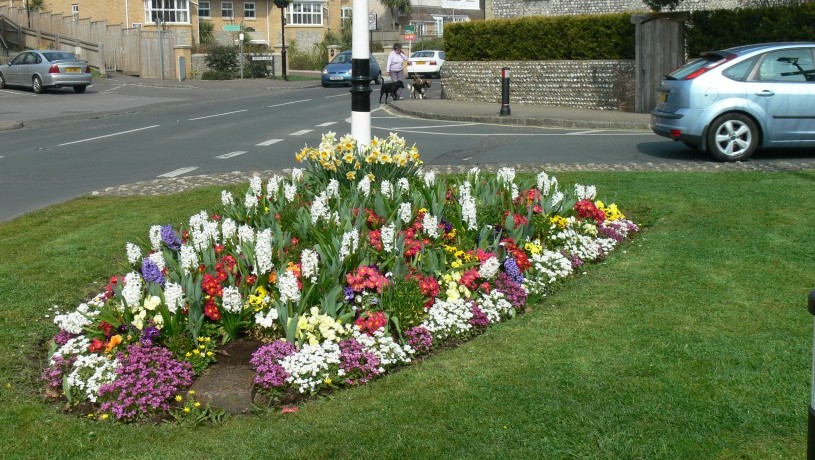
[0,171,815,460]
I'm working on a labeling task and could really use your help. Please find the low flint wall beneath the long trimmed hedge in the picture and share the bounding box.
[442,60,635,112]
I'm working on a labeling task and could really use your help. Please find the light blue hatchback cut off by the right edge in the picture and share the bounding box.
[651,42,815,161]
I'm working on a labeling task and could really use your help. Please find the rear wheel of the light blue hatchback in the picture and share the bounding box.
[707,113,759,161]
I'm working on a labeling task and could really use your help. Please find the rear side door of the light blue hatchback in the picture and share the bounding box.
[748,48,815,143]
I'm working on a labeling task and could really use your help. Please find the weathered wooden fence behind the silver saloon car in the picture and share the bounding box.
[0,6,179,79]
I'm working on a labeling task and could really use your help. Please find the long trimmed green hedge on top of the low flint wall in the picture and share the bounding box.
[444,13,634,61]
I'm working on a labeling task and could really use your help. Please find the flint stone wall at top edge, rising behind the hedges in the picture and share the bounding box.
[486,0,789,19]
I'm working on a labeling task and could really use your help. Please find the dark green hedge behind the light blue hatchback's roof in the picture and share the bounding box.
[685,3,815,56]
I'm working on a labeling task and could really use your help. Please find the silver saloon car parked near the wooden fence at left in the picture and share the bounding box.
[0,50,92,94]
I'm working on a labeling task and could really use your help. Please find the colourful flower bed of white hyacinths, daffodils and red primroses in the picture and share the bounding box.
[43,133,637,421]
